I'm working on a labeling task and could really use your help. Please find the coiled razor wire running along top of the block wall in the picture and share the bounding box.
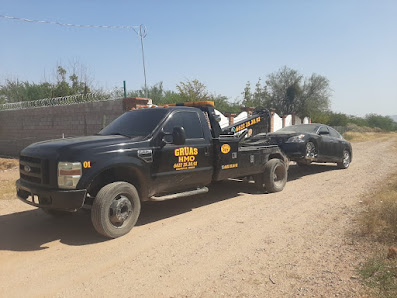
[0,90,122,111]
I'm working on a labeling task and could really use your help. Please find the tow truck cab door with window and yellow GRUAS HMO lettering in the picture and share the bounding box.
[152,111,213,193]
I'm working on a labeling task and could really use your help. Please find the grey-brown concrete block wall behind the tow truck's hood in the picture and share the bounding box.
[0,98,147,157]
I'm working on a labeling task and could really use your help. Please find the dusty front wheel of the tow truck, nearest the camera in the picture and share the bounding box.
[91,182,141,238]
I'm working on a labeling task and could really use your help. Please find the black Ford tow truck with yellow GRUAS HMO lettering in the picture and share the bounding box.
[16,102,288,238]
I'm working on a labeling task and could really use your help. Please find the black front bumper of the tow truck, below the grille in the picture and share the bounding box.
[16,179,87,211]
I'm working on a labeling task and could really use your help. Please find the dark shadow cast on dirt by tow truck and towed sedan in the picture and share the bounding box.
[0,164,336,251]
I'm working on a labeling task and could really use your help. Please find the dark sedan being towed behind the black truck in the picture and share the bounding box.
[267,123,353,169]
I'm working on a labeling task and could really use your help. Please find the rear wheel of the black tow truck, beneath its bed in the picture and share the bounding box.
[264,159,288,193]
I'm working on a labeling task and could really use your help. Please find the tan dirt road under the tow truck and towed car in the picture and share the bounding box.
[0,140,397,297]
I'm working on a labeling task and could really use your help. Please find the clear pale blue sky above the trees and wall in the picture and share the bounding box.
[0,0,397,116]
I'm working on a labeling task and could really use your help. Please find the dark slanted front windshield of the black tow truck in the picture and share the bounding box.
[98,108,167,137]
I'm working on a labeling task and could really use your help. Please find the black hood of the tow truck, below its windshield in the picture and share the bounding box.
[21,135,143,159]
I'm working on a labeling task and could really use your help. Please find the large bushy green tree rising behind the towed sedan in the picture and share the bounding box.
[242,67,331,117]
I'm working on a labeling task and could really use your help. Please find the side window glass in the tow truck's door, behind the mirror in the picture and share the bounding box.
[164,112,203,139]
